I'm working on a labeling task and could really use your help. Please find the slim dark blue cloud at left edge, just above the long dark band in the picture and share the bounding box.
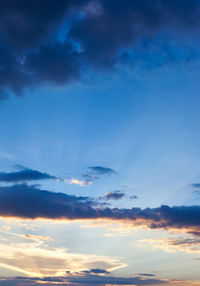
[0,167,56,183]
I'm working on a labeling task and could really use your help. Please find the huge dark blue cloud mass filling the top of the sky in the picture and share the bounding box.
[0,0,200,95]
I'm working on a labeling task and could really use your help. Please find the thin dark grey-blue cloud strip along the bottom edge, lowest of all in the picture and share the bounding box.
[0,274,167,286]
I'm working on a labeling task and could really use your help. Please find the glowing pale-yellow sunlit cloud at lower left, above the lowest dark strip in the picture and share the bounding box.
[0,237,124,278]
